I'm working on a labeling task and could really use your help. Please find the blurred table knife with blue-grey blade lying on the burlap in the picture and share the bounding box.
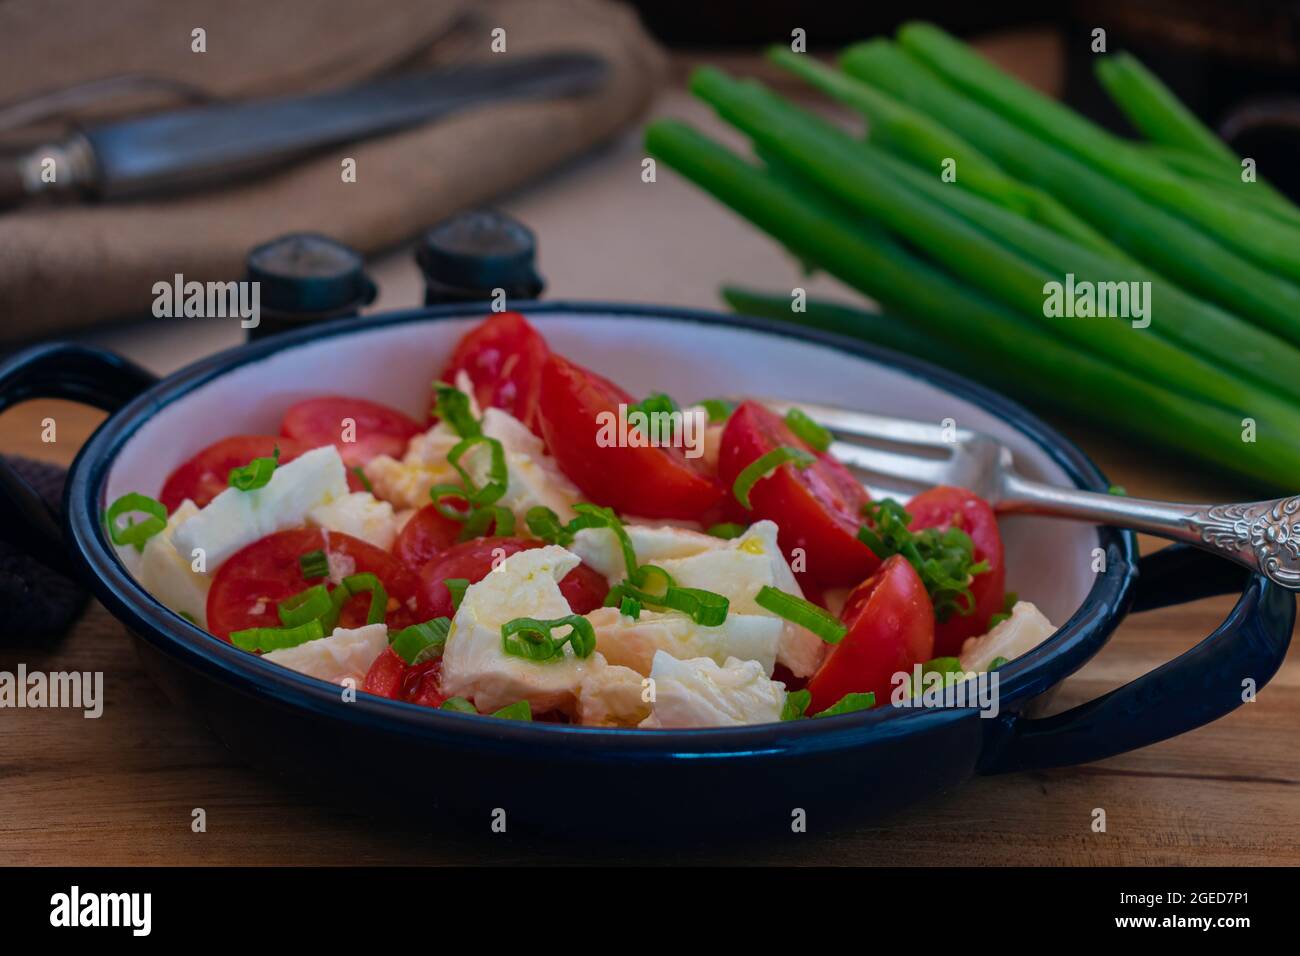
[0,53,607,203]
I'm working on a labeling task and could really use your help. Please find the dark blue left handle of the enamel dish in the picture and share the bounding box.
[0,342,157,579]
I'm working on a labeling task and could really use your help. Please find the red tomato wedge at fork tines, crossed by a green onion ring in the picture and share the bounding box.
[718,402,880,588]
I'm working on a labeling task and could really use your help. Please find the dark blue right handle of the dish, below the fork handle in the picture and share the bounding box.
[979,545,1296,774]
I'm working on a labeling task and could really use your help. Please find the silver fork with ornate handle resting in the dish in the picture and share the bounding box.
[763,401,1300,591]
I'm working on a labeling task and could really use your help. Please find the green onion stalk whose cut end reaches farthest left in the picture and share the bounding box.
[646,120,1300,488]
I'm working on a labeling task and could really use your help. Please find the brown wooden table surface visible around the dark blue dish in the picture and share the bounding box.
[0,42,1300,866]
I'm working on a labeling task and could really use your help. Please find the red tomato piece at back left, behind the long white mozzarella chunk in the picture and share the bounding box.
[280,395,424,468]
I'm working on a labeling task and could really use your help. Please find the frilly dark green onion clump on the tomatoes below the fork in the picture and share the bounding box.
[858,498,988,623]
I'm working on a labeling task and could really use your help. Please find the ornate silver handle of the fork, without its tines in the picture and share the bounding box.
[997,473,1300,591]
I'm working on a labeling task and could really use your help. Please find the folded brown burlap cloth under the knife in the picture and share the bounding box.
[0,0,663,341]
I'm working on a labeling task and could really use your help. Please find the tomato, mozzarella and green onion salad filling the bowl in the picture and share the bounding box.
[104,312,1054,728]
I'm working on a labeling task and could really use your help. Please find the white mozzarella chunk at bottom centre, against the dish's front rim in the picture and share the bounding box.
[640,650,785,730]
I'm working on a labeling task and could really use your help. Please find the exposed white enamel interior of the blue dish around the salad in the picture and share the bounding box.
[107,313,1097,626]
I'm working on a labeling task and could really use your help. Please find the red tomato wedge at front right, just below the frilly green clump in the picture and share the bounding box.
[807,554,935,714]
